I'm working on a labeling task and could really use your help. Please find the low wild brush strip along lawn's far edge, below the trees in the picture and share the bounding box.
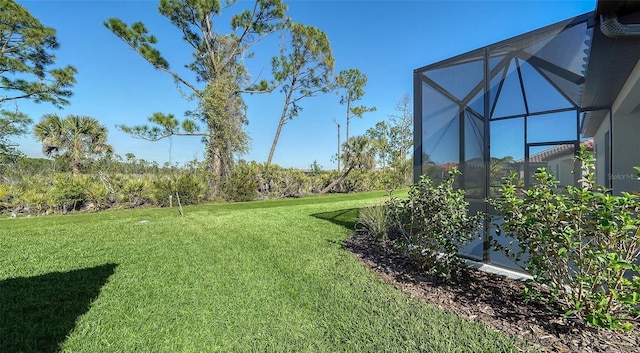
[0,155,400,215]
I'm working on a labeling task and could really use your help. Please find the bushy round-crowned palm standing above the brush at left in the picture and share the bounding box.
[34,114,112,176]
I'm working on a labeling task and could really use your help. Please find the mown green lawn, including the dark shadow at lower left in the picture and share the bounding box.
[0,192,520,352]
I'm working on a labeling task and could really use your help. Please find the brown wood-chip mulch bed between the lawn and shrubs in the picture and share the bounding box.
[344,233,640,353]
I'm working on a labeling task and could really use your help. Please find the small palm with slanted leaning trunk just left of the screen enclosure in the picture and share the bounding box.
[320,136,376,194]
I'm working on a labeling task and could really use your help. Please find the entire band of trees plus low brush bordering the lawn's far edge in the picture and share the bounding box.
[0,0,412,215]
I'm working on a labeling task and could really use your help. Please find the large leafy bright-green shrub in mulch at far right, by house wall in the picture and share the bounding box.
[491,149,640,329]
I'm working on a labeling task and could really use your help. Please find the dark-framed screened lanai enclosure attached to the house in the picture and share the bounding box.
[414,13,640,268]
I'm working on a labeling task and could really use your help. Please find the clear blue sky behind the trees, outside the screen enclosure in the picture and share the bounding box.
[11,0,595,169]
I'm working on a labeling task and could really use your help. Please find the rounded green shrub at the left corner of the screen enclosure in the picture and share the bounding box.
[386,168,481,280]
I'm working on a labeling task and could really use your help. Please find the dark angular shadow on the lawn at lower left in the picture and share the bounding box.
[0,264,117,353]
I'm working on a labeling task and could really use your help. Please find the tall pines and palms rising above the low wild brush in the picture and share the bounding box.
[0,0,412,210]
